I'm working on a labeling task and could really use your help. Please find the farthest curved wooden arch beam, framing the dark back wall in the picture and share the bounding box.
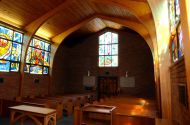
[49,14,154,94]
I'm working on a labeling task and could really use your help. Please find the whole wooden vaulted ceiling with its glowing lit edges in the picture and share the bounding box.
[0,0,155,50]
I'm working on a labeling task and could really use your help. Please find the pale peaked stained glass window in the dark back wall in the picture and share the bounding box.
[99,32,118,67]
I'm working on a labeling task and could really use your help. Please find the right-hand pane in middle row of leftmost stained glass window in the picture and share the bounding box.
[11,43,21,61]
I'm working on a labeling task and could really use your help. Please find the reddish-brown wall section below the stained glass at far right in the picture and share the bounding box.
[170,58,190,125]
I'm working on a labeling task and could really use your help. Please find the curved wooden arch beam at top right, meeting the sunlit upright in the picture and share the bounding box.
[90,0,157,50]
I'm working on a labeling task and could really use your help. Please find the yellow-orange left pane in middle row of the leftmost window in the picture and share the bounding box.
[0,38,12,60]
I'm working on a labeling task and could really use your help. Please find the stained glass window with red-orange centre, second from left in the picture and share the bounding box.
[24,38,51,74]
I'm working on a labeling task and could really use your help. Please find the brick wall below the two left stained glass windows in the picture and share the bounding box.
[0,72,49,99]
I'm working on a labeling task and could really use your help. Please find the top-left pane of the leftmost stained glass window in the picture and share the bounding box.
[0,26,13,40]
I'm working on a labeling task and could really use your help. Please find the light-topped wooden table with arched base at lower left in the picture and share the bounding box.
[10,105,56,125]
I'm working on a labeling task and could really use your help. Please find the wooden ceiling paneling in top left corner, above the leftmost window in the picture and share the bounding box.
[0,0,63,26]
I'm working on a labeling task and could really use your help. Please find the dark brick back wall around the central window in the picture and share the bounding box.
[53,30,155,97]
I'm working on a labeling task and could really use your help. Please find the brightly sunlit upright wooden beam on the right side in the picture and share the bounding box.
[147,0,172,119]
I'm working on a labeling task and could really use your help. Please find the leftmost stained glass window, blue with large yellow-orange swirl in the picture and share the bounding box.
[0,26,23,72]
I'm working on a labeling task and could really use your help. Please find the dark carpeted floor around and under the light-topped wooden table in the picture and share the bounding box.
[0,116,73,125]
